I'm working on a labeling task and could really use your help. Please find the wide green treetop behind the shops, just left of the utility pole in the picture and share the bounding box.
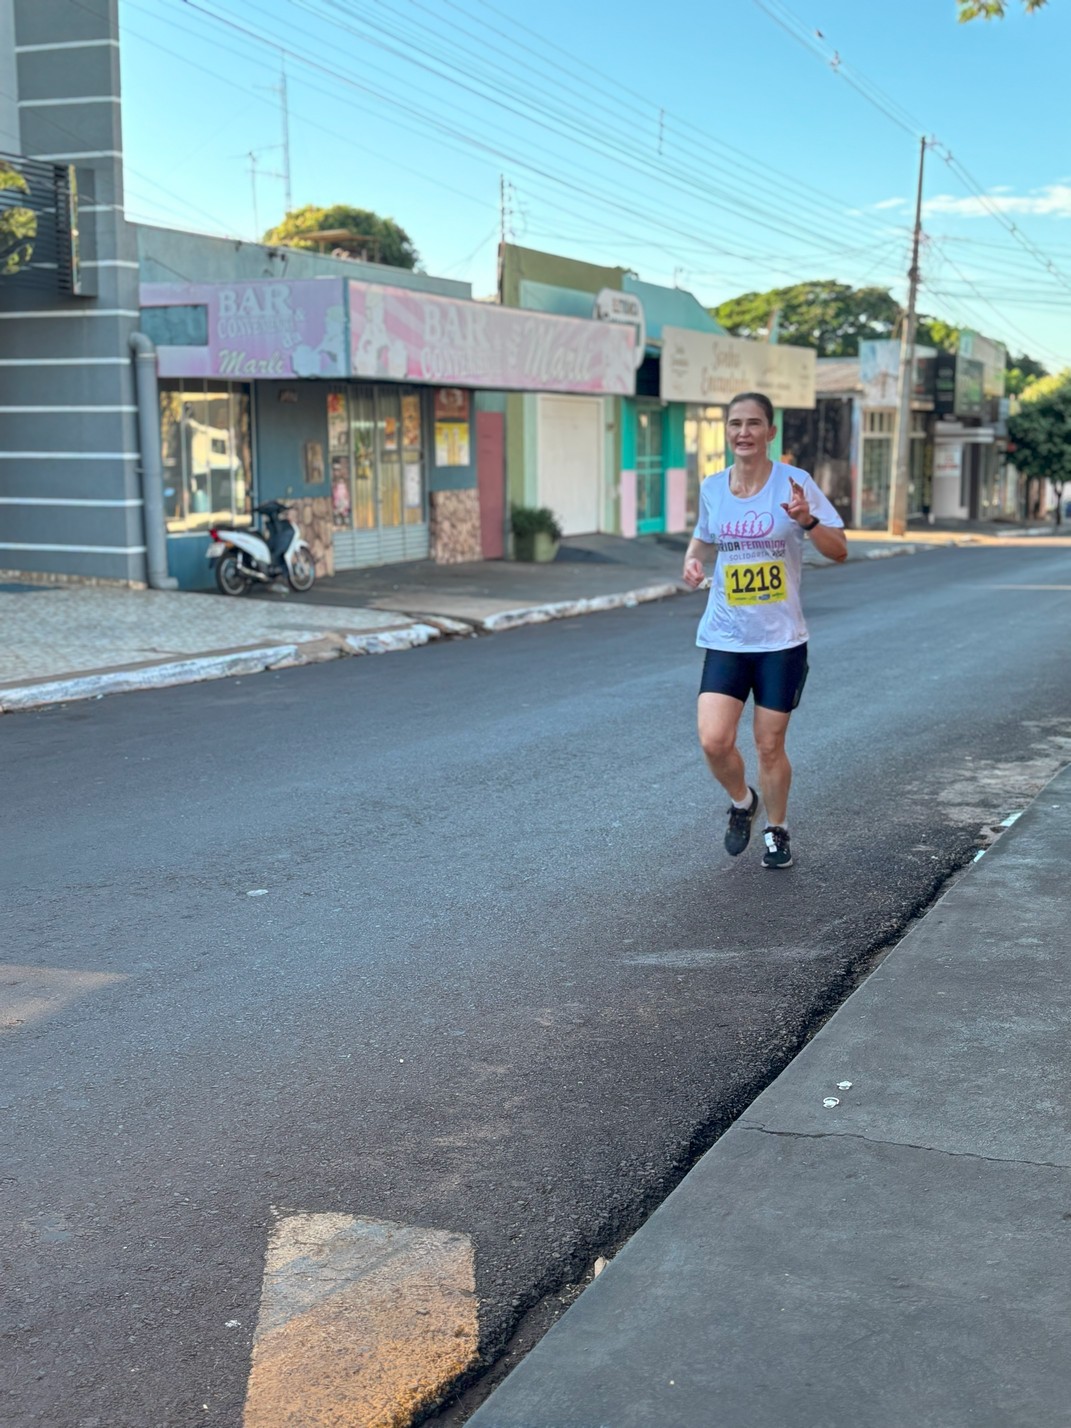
[711,281,902,357]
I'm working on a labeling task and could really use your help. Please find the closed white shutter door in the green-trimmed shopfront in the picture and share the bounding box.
[538,397,603,536]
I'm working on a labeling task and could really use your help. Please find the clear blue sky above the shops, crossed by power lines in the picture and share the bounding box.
[120,0,1071,366]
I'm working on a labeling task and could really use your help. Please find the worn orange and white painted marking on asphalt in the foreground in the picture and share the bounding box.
[243,1214,478,1428]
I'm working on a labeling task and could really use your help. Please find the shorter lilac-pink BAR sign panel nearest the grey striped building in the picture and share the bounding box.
[141,278,347,380]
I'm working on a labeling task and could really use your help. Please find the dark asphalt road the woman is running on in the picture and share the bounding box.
[0,548,1071,1428]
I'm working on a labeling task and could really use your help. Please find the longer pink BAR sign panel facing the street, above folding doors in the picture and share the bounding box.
[350,281,635,396]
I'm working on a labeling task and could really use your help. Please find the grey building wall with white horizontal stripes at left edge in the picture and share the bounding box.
[0,0,146,584]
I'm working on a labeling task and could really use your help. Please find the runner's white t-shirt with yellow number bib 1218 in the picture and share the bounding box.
[695,461,844,654]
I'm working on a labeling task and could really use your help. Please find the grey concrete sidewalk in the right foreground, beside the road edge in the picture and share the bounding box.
[470,770,1071,1428]
